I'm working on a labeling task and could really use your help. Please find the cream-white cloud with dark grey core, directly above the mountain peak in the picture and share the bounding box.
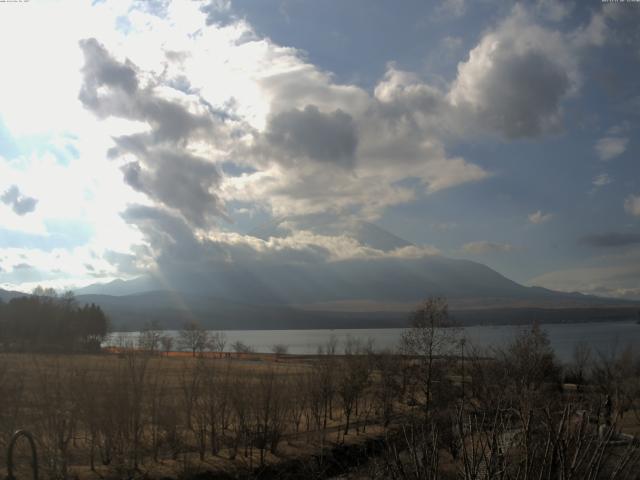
[222,59,490,219]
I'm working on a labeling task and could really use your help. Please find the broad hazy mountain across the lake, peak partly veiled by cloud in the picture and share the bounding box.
[71,218,638,329]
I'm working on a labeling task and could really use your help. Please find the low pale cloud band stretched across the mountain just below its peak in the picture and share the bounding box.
[117,205,440,278]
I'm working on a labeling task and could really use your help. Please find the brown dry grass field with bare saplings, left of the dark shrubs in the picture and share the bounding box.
[0,351,398,478]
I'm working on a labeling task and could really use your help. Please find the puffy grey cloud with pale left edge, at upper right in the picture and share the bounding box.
[448,5,604,138]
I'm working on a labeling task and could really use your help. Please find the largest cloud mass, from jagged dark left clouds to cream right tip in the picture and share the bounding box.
[74,20,490,229]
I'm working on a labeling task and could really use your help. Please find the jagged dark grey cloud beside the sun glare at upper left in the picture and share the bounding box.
[79,39,224,227]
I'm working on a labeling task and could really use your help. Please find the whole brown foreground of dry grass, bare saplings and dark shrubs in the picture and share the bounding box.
[0,318,640,480]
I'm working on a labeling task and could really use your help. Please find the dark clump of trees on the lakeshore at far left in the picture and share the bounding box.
[0,287,109,353]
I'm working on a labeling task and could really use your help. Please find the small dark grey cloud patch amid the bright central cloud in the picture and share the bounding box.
[266,105,358,167]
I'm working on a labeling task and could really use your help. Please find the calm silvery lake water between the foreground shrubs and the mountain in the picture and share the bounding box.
[105,321,640,361]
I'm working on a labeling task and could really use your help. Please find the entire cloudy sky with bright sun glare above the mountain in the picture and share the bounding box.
[0,0,640,299]
